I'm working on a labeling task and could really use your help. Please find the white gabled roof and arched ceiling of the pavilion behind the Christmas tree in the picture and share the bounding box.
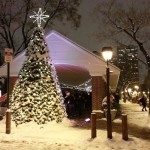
[0,31,120,89]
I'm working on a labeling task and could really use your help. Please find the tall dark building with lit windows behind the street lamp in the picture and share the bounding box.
[111,46,139,92]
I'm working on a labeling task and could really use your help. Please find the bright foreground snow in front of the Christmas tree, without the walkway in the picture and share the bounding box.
[0,116,150,150]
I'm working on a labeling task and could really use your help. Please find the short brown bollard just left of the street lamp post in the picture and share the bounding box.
[91,113,96,138]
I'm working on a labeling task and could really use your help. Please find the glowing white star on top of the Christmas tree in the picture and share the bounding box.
[30,8,49,27]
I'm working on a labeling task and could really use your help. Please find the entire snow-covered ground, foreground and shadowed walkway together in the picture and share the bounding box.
[0,100,150,150]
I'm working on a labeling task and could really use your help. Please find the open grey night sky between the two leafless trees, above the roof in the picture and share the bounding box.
[54,0,100,51]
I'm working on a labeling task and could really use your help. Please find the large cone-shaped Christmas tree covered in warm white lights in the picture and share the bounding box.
[10,7,66,125]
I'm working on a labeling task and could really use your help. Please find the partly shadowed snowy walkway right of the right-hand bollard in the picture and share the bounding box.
[115,102,150,140]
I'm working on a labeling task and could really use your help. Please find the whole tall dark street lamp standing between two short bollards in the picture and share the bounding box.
[102,47,113,139]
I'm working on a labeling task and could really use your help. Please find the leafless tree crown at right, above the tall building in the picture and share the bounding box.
[94,0,150,89]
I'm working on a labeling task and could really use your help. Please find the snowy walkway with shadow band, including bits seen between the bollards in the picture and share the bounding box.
[97,102,150,141]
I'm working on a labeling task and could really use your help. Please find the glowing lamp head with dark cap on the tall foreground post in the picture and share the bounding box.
[102,47,113,61]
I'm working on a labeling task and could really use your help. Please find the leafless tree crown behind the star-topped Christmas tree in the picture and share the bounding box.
[0,0,82,55]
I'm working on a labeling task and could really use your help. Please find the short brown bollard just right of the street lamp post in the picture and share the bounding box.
[122,114,128,140]
